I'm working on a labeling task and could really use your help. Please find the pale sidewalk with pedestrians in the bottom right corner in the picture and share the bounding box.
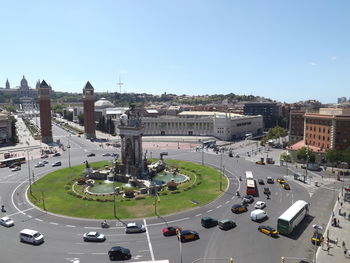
[316,195,350,263]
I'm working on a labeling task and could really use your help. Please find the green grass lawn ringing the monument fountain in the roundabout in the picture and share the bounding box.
[28,160,227,219]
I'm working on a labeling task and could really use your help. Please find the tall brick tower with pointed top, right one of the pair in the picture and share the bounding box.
[83,81,96,139]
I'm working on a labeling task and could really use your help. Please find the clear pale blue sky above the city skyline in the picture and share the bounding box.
[0,0,350,102]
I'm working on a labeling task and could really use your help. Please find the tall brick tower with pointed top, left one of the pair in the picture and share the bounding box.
[38,80,52,143]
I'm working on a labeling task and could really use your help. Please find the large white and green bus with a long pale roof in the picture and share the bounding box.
[277,200,309,235]
